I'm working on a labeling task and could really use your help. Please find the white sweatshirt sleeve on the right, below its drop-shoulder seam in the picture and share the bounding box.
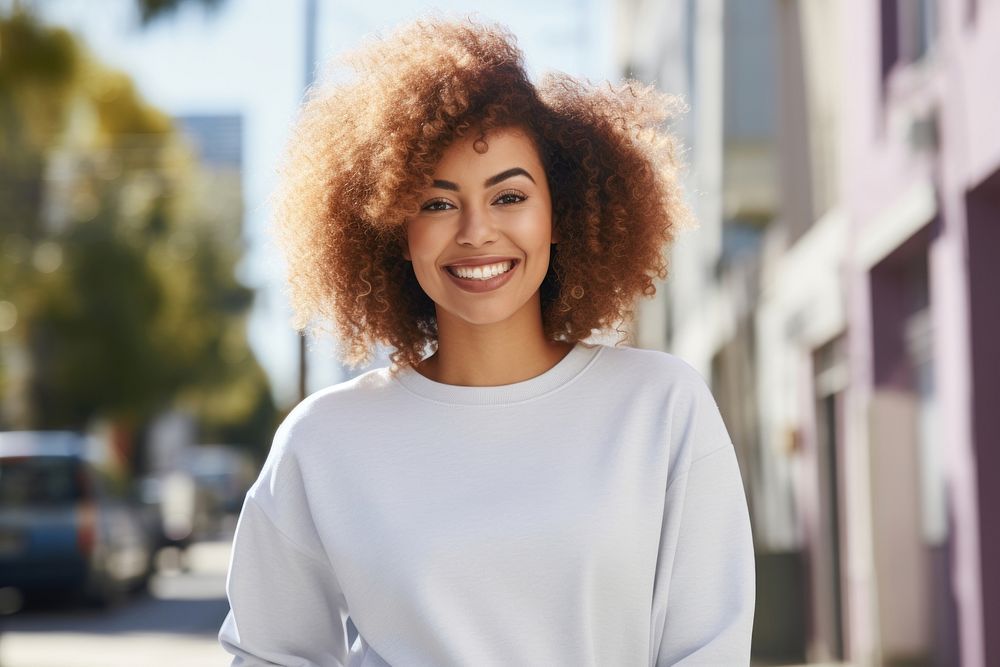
[654,443,756,667]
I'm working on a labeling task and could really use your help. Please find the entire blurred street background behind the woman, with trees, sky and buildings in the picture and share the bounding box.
[0,0,1000,667]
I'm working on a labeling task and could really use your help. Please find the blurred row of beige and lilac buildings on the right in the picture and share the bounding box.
[618,0,1000,666]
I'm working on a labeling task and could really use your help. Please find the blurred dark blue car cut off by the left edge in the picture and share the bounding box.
[0,431,153,606]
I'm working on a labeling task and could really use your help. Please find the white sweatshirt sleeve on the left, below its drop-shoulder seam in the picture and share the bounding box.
[219,497,348,667]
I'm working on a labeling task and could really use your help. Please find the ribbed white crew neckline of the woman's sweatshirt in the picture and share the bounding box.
[395,342,604,405]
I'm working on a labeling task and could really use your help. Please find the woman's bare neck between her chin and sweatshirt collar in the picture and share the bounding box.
[417,294,573,387]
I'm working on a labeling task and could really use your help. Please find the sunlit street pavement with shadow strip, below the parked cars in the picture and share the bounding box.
[0,541,231,667]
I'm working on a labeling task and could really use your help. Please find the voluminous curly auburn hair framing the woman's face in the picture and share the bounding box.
[272,19,689,368]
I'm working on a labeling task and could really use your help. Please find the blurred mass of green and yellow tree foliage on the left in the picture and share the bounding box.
[0,7,274,460]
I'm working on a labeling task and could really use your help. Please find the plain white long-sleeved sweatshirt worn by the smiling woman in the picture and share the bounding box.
[219,343,755,667]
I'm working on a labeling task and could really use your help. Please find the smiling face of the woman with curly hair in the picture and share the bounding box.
[403,128,553,325]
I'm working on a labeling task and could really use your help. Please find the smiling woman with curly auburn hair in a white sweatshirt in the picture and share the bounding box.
[219,15,754,667]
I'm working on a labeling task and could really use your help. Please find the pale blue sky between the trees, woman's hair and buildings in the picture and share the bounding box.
[33,0,616,406]
